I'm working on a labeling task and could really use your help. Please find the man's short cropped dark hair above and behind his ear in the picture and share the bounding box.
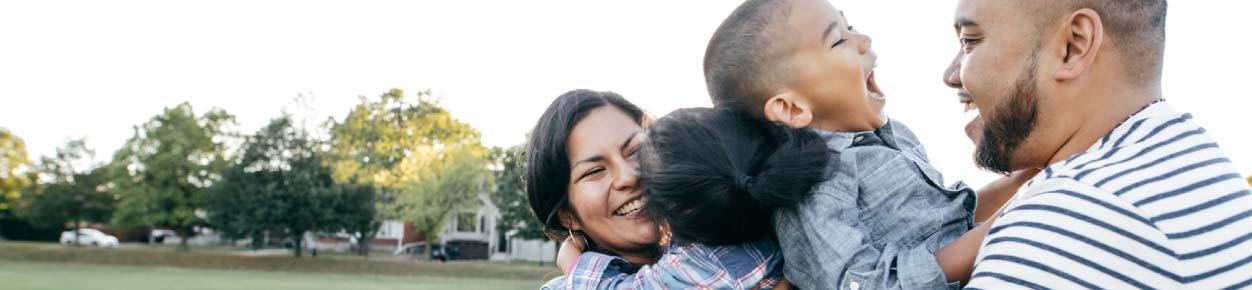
[1033,0,1168,83]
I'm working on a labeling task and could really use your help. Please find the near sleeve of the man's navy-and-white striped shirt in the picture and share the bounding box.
[972,179,1178,289]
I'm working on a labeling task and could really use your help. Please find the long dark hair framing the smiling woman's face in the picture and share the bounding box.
[525,90,646,241]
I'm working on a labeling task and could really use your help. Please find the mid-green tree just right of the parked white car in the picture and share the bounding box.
[109,103,234,251]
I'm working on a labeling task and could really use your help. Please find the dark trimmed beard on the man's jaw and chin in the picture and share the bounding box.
[974,56,1039,175]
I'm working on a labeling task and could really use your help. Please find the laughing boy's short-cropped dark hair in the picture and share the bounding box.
[704,0,791,115]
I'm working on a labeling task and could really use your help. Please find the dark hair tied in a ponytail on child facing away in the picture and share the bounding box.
[641,108,830,245]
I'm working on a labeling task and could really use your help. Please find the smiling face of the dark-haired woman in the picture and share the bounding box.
[567,106,661,263]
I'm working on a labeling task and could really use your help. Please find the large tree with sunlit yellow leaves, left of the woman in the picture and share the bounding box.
[328,89,491,258]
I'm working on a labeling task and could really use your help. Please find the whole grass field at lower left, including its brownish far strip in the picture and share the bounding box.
[0,241,558,290]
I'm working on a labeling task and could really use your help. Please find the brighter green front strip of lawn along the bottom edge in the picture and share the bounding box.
[0,260,538,290]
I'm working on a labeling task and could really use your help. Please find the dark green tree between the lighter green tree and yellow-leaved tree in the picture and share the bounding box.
[209,115,341,258]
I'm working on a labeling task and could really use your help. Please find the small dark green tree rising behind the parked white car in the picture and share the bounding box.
[20,139,114,245]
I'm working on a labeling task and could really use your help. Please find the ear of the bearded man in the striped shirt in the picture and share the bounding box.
[1055,9,1104,81]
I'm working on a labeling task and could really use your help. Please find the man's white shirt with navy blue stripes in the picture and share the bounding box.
[968,103,1252,289]
